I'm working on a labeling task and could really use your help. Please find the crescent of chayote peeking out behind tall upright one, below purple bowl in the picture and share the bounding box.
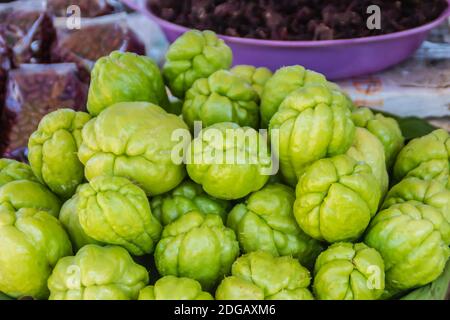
[261,65,328,128]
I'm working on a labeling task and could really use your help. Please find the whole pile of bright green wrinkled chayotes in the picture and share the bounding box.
[0,30,450,300]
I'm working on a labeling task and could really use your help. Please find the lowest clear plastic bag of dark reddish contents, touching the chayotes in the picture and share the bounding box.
[0,63,87,160]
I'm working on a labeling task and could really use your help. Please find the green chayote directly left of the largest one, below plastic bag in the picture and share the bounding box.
[28,109,91,199]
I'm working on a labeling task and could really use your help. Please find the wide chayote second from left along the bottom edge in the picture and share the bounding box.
[48,244,148,300]
